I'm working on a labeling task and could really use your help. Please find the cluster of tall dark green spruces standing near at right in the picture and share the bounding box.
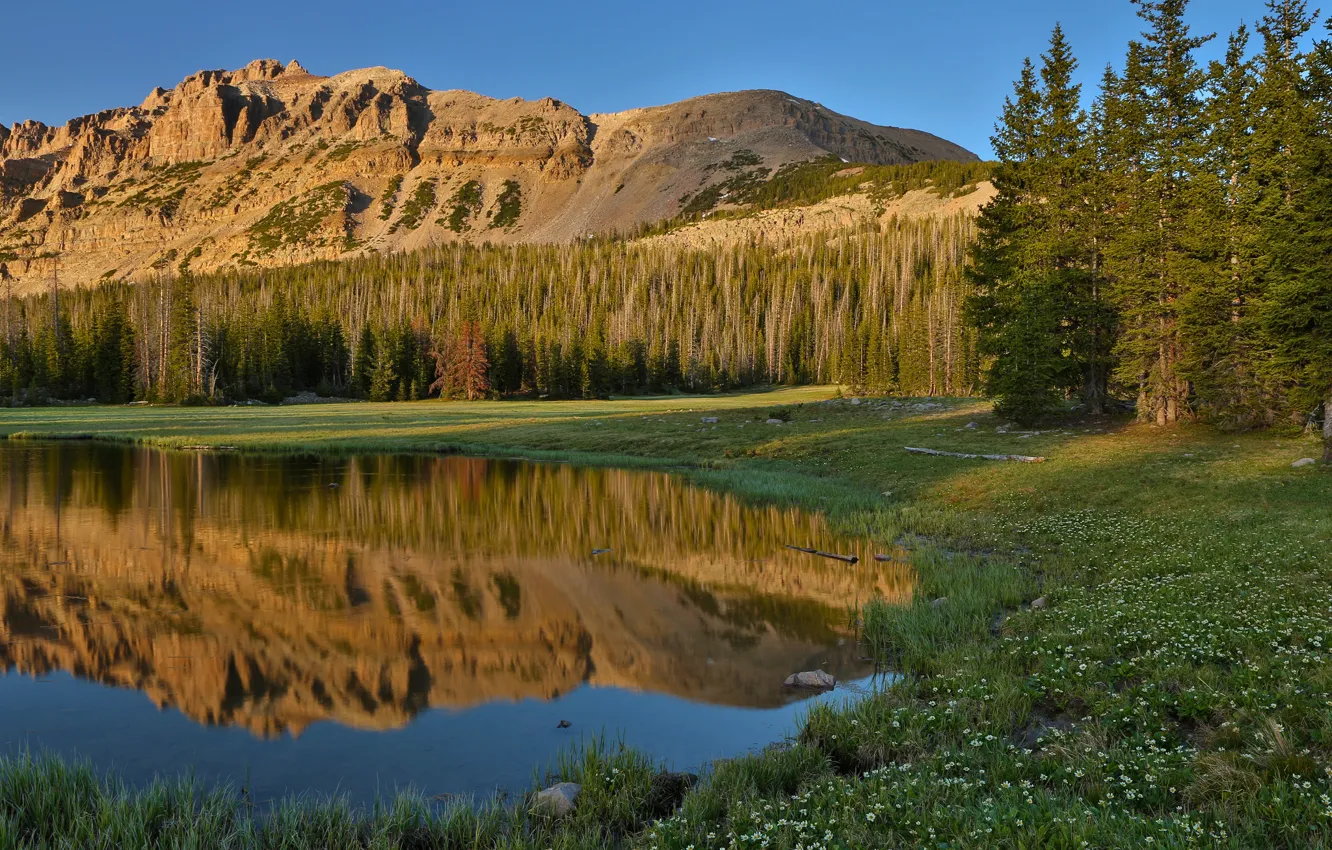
[966,0,1332,454]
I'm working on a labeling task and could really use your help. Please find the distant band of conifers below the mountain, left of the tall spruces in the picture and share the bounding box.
[0,216,980,404]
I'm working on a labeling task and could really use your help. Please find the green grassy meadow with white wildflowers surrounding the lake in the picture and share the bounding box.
[0,388,1332,850]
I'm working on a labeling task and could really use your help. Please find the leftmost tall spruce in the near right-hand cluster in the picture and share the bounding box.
[967,27,1107,422]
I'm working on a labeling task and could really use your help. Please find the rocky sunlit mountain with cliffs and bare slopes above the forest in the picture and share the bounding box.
[0,60,978,293]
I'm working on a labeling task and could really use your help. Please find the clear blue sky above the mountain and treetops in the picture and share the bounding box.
[0,0,1294,156]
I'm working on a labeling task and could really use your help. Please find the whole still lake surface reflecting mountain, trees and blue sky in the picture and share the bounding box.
[0,444,912,801]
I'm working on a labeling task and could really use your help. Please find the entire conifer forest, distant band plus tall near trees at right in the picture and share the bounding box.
[0,0,1332,466]
